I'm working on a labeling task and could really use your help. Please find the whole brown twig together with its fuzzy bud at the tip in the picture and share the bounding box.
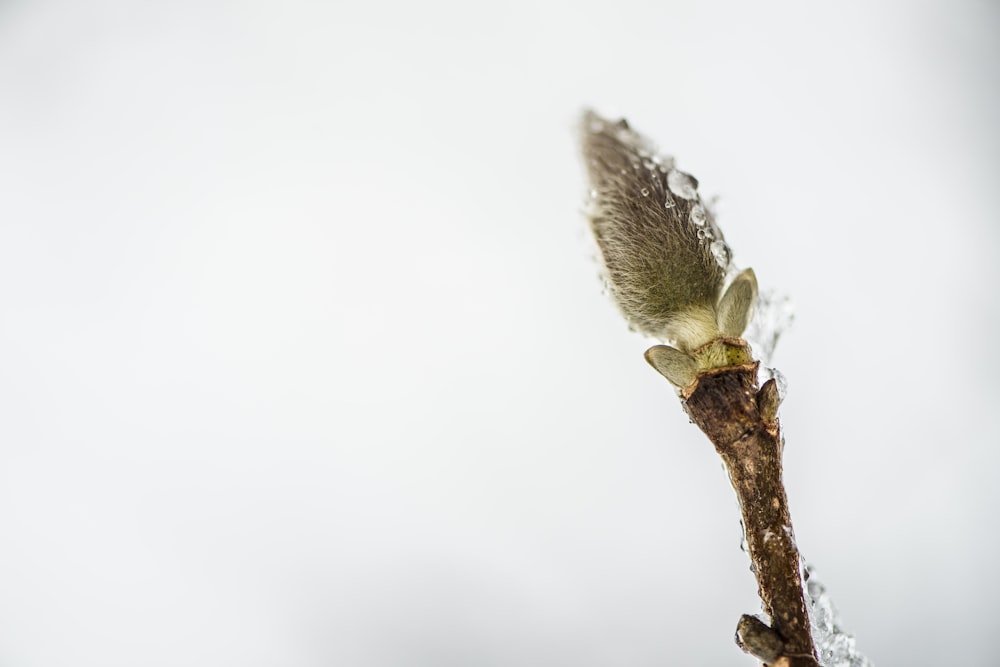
[581,112,818,667]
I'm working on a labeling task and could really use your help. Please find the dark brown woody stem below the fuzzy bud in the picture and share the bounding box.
[682,363,819,667]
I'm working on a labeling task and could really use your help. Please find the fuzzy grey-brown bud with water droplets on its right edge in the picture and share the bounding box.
[580,111,756,351]
